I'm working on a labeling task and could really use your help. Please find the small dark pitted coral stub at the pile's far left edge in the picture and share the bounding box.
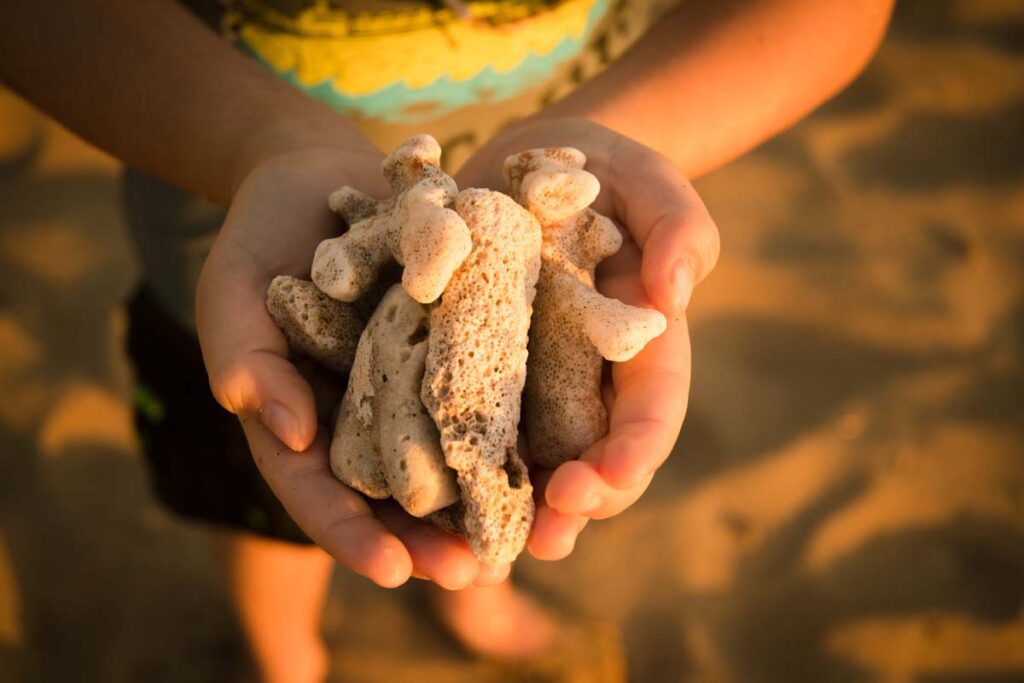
[266,275,364,373]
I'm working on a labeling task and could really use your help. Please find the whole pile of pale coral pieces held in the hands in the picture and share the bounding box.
[267,135,666,563]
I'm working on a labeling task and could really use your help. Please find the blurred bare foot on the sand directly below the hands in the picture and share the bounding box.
[433,581,555,661]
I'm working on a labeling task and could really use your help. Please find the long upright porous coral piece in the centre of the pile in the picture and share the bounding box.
[422,189,541,563]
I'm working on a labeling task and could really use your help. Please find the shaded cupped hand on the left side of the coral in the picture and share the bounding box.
[196,145,508,589]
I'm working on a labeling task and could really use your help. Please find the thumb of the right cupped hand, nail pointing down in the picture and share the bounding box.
[611,138,720,315]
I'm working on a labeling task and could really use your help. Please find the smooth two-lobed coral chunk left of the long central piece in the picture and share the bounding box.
[331,285,459,517]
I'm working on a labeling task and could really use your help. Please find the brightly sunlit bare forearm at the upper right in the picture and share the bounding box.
[540,0,892,177]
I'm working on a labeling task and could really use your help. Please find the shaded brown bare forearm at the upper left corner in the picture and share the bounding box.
[0,0,370,203]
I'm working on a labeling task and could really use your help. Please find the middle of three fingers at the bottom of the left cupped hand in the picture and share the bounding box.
[372,502,479,591]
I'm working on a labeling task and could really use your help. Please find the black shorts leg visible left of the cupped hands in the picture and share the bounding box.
[127,286,310,544]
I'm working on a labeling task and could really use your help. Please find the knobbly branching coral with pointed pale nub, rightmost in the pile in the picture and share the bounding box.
[504,147,667,467]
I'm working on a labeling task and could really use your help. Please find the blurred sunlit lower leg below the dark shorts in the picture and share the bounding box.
[218,532,334,683]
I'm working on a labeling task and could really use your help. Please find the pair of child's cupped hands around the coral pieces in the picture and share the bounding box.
[197,120,719,589]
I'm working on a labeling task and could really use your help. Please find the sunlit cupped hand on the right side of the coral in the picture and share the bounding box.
[456,119,719,560]
